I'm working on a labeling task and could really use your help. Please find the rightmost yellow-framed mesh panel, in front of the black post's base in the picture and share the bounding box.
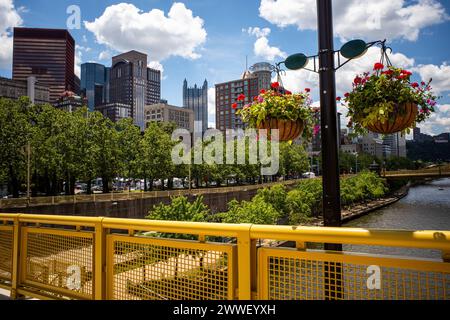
[260,251,450,300]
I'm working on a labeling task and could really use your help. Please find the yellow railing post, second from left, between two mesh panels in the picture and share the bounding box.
[94,218,106,300]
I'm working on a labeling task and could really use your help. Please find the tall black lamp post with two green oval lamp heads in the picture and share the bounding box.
[277,0,387,235]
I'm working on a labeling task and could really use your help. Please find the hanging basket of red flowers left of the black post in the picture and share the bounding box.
[236,82,312,141]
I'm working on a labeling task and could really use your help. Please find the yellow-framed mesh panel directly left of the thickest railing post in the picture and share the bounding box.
[108,237,232,300]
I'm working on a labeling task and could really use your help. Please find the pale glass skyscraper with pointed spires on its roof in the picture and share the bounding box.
[183,79,208,133]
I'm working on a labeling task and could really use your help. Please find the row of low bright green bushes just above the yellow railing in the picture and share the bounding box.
[148,171,388,225]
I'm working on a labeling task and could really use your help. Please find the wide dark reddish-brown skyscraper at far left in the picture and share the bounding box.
[13,28,76,102]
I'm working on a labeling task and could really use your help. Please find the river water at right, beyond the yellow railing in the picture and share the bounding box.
[344,179,450,259]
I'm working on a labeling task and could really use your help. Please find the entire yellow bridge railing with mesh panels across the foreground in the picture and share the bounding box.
[0,214,450,300]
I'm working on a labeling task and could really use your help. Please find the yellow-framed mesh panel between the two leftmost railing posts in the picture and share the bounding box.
[22,229,93,299]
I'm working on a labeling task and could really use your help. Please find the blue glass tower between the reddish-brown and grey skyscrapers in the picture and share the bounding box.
[81,63,110,111]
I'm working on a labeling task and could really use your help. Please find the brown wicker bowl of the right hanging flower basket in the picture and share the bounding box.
[366,103,418,134]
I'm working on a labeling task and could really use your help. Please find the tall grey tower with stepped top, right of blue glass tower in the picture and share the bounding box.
[110,50,161,130]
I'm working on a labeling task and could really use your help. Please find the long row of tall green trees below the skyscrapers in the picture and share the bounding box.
[0,98,308,197]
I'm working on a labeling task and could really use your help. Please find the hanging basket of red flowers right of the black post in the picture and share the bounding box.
[338,63,437,134]
